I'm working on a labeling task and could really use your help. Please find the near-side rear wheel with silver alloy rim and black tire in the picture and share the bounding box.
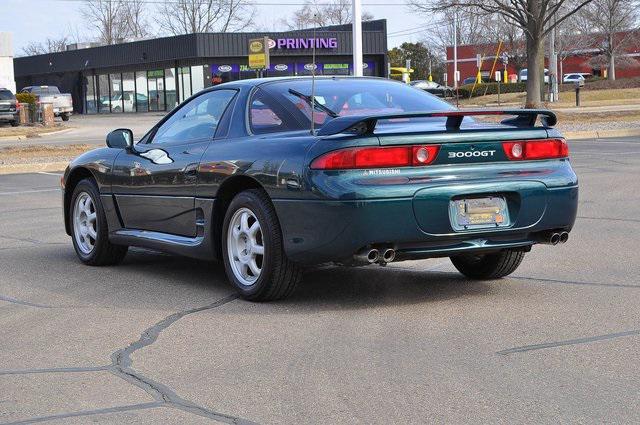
[222,189,302,301]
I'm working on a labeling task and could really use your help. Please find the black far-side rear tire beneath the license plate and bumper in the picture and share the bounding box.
[451,250,524,280]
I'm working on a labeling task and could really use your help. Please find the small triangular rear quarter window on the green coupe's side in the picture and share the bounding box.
[249,90,300,134]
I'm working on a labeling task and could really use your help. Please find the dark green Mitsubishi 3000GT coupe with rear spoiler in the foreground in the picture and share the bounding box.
[61,77,578,300]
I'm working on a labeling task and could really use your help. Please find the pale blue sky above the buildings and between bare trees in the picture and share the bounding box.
[0,0,425,56]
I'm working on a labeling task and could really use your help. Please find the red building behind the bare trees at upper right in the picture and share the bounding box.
[446,32,640,86]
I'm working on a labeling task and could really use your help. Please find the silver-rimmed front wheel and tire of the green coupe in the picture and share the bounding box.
[69,179,128,266]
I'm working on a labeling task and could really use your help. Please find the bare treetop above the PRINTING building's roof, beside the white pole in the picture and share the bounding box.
[282,0,373,30]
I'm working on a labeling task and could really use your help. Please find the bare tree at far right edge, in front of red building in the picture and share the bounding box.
[578,0,640,80]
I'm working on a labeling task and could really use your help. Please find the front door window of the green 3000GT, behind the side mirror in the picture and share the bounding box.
[151,90,236,144]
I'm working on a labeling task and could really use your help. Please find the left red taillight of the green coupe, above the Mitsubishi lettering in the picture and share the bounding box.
[311,145,440,170]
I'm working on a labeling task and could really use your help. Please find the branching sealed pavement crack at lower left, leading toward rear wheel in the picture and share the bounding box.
[0,294,255,425]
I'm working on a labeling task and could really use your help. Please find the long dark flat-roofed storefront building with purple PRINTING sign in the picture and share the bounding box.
[14,19,387,114]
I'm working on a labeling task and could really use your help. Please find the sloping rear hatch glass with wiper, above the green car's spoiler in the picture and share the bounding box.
[261,78,455,125]
